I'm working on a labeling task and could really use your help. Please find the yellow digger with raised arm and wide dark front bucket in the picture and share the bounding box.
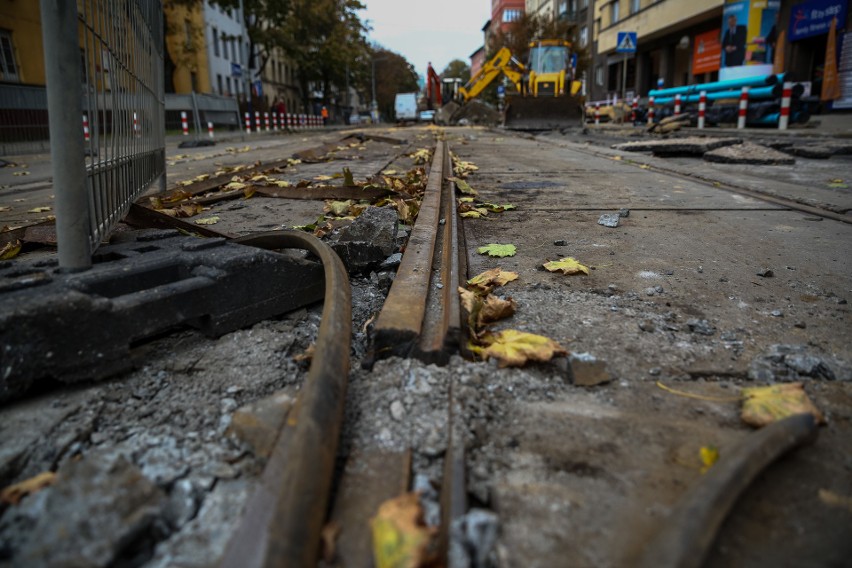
[459,39,583,130]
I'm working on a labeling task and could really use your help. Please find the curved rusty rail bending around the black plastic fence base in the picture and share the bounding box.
[220,231,352,568]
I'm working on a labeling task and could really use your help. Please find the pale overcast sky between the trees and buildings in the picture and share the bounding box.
[361,0,491,76]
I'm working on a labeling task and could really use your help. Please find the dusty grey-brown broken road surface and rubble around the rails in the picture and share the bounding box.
[0,127,852,567]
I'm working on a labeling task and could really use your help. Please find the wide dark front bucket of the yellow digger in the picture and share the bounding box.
[503,96,583,130]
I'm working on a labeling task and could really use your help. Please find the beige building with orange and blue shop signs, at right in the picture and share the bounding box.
[590,0,852,105]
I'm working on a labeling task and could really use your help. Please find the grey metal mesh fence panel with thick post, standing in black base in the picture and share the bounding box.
[41,0,165,270]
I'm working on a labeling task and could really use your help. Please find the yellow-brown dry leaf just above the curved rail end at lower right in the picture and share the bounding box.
[741,383,825,428]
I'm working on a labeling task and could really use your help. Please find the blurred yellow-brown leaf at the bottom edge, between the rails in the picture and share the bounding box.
[370,493,436,568]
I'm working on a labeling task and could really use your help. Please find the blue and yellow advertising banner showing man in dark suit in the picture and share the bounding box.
[719,0,781,81]
